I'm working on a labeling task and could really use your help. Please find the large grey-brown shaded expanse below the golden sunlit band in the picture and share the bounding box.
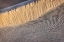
[0,3,64,42]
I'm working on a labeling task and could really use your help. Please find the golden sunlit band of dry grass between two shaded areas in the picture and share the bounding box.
[0,0,64,27]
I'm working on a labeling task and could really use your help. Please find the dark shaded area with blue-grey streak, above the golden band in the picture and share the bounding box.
[0,0,37,13]
